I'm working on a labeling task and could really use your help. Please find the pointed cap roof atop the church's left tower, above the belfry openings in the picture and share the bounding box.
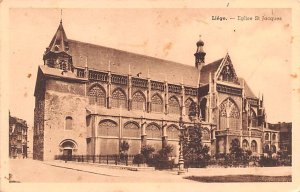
[46,19,69,54]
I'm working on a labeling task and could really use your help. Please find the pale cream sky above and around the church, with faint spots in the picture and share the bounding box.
[9,8,292,125]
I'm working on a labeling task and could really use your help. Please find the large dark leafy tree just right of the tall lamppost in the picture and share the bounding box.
[180,125,210,167]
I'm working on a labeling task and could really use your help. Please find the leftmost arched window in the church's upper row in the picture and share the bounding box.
[88,85,106,107]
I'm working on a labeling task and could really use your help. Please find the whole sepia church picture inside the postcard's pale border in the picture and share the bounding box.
[1,3,298,191]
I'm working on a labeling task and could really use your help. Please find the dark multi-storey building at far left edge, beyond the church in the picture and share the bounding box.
[9,114,28,158]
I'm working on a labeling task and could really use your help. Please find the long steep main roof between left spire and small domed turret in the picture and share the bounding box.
[68,39,199,87]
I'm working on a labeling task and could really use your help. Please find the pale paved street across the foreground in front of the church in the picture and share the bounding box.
[10,159,291,183]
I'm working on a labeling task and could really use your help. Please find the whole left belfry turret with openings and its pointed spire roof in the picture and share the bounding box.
[43,21,73,71]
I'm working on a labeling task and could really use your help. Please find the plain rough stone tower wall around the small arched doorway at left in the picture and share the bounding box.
[44,80,87,160]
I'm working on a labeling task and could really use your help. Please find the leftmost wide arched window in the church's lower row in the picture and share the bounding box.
[98,119,119,137]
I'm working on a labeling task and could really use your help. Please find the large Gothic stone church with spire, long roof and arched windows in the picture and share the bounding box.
[33,22,278,160]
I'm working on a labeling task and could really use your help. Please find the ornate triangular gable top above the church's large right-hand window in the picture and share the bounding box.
[216,53,239,84]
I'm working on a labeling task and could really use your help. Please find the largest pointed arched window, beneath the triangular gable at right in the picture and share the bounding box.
[219,98,240,130]
